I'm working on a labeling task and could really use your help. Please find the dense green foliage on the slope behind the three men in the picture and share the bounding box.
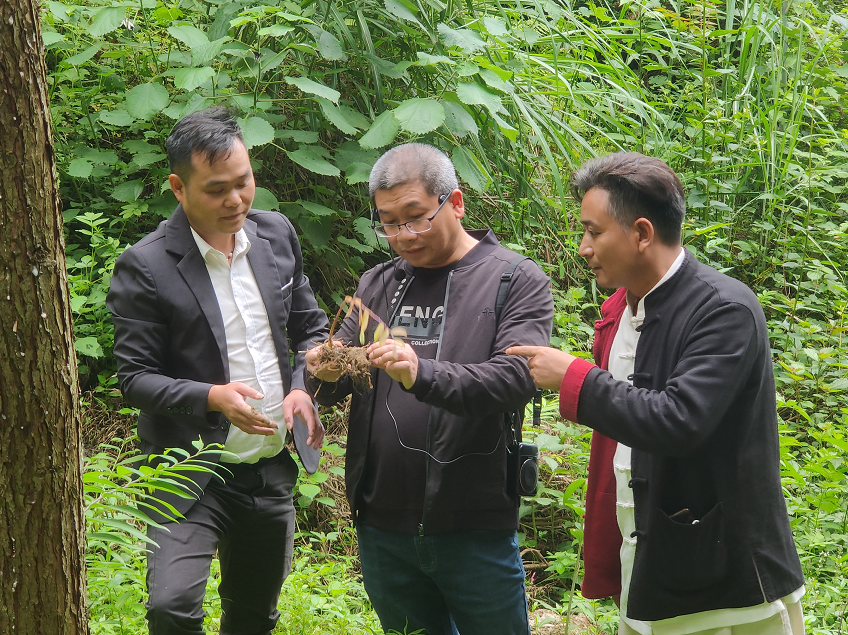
[51,0,848,633]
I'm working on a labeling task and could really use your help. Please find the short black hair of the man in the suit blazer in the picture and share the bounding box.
[165,106,244,181]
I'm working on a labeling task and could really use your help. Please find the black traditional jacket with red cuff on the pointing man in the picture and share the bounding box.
[577,252,804,620]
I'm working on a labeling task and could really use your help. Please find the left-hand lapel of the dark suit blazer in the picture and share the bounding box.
[165,205,230,382]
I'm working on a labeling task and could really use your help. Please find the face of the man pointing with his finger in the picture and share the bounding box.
[578,187,640,288]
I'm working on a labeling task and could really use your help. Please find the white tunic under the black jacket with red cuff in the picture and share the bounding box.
[609,249,804,635]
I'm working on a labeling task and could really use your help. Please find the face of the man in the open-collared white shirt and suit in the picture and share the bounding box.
[170,139,256,246]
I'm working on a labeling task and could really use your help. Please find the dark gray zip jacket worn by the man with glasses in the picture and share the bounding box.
[307,230,553,535]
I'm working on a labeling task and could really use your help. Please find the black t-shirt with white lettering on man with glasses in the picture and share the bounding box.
[360,265,455,534]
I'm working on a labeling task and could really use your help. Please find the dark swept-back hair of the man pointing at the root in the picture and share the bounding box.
[571,152,686,245]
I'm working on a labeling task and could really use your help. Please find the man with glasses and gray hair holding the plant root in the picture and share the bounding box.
[306,144,553,635]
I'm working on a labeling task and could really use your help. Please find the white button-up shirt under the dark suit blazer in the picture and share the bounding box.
[191,229,287,463]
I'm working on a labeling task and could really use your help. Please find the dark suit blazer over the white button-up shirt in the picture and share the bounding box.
[106,205,327,513]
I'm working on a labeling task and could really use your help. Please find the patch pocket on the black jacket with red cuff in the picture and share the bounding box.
[644,503,728,592]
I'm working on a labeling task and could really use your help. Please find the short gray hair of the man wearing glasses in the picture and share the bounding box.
[368,143,459,201]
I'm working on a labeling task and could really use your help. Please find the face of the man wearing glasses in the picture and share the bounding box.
[374,182,465,269]
